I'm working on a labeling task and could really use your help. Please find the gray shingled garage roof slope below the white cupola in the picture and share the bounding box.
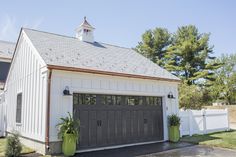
[23,28,179,80]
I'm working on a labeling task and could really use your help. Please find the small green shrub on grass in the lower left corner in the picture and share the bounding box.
[5,133,22,157]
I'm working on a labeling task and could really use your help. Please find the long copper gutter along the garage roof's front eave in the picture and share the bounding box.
[47,64,181,83]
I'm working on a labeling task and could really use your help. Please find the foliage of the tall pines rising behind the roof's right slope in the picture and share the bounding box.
[136,25,220,85]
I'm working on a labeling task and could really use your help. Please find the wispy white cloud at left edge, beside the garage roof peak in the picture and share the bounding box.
[0,14,44,42]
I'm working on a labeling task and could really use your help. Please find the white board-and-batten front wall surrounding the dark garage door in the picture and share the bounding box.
[50,70,178,141]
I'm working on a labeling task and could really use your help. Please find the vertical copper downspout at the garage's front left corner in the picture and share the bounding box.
[45,69,52,151]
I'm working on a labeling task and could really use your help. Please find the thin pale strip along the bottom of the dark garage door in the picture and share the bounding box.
[76,140,165,153]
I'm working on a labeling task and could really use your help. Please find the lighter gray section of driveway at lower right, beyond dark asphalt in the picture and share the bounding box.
[138,145,236,157]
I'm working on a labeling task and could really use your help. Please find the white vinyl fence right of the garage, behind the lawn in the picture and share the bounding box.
[179,109,229,136]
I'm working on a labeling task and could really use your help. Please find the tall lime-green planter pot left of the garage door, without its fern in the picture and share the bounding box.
[62,133,77,156]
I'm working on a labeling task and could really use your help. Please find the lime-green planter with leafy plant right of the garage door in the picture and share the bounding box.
[168,114,180,142]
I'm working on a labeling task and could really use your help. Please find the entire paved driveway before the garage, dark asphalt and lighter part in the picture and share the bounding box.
[25,142,236,157]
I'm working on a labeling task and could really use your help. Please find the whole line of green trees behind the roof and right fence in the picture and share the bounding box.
[135,25,236,109]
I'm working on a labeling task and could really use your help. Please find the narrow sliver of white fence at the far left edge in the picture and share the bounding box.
[0,93,6,137]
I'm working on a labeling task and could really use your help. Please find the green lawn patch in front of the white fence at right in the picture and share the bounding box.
[181,130,236,149]
